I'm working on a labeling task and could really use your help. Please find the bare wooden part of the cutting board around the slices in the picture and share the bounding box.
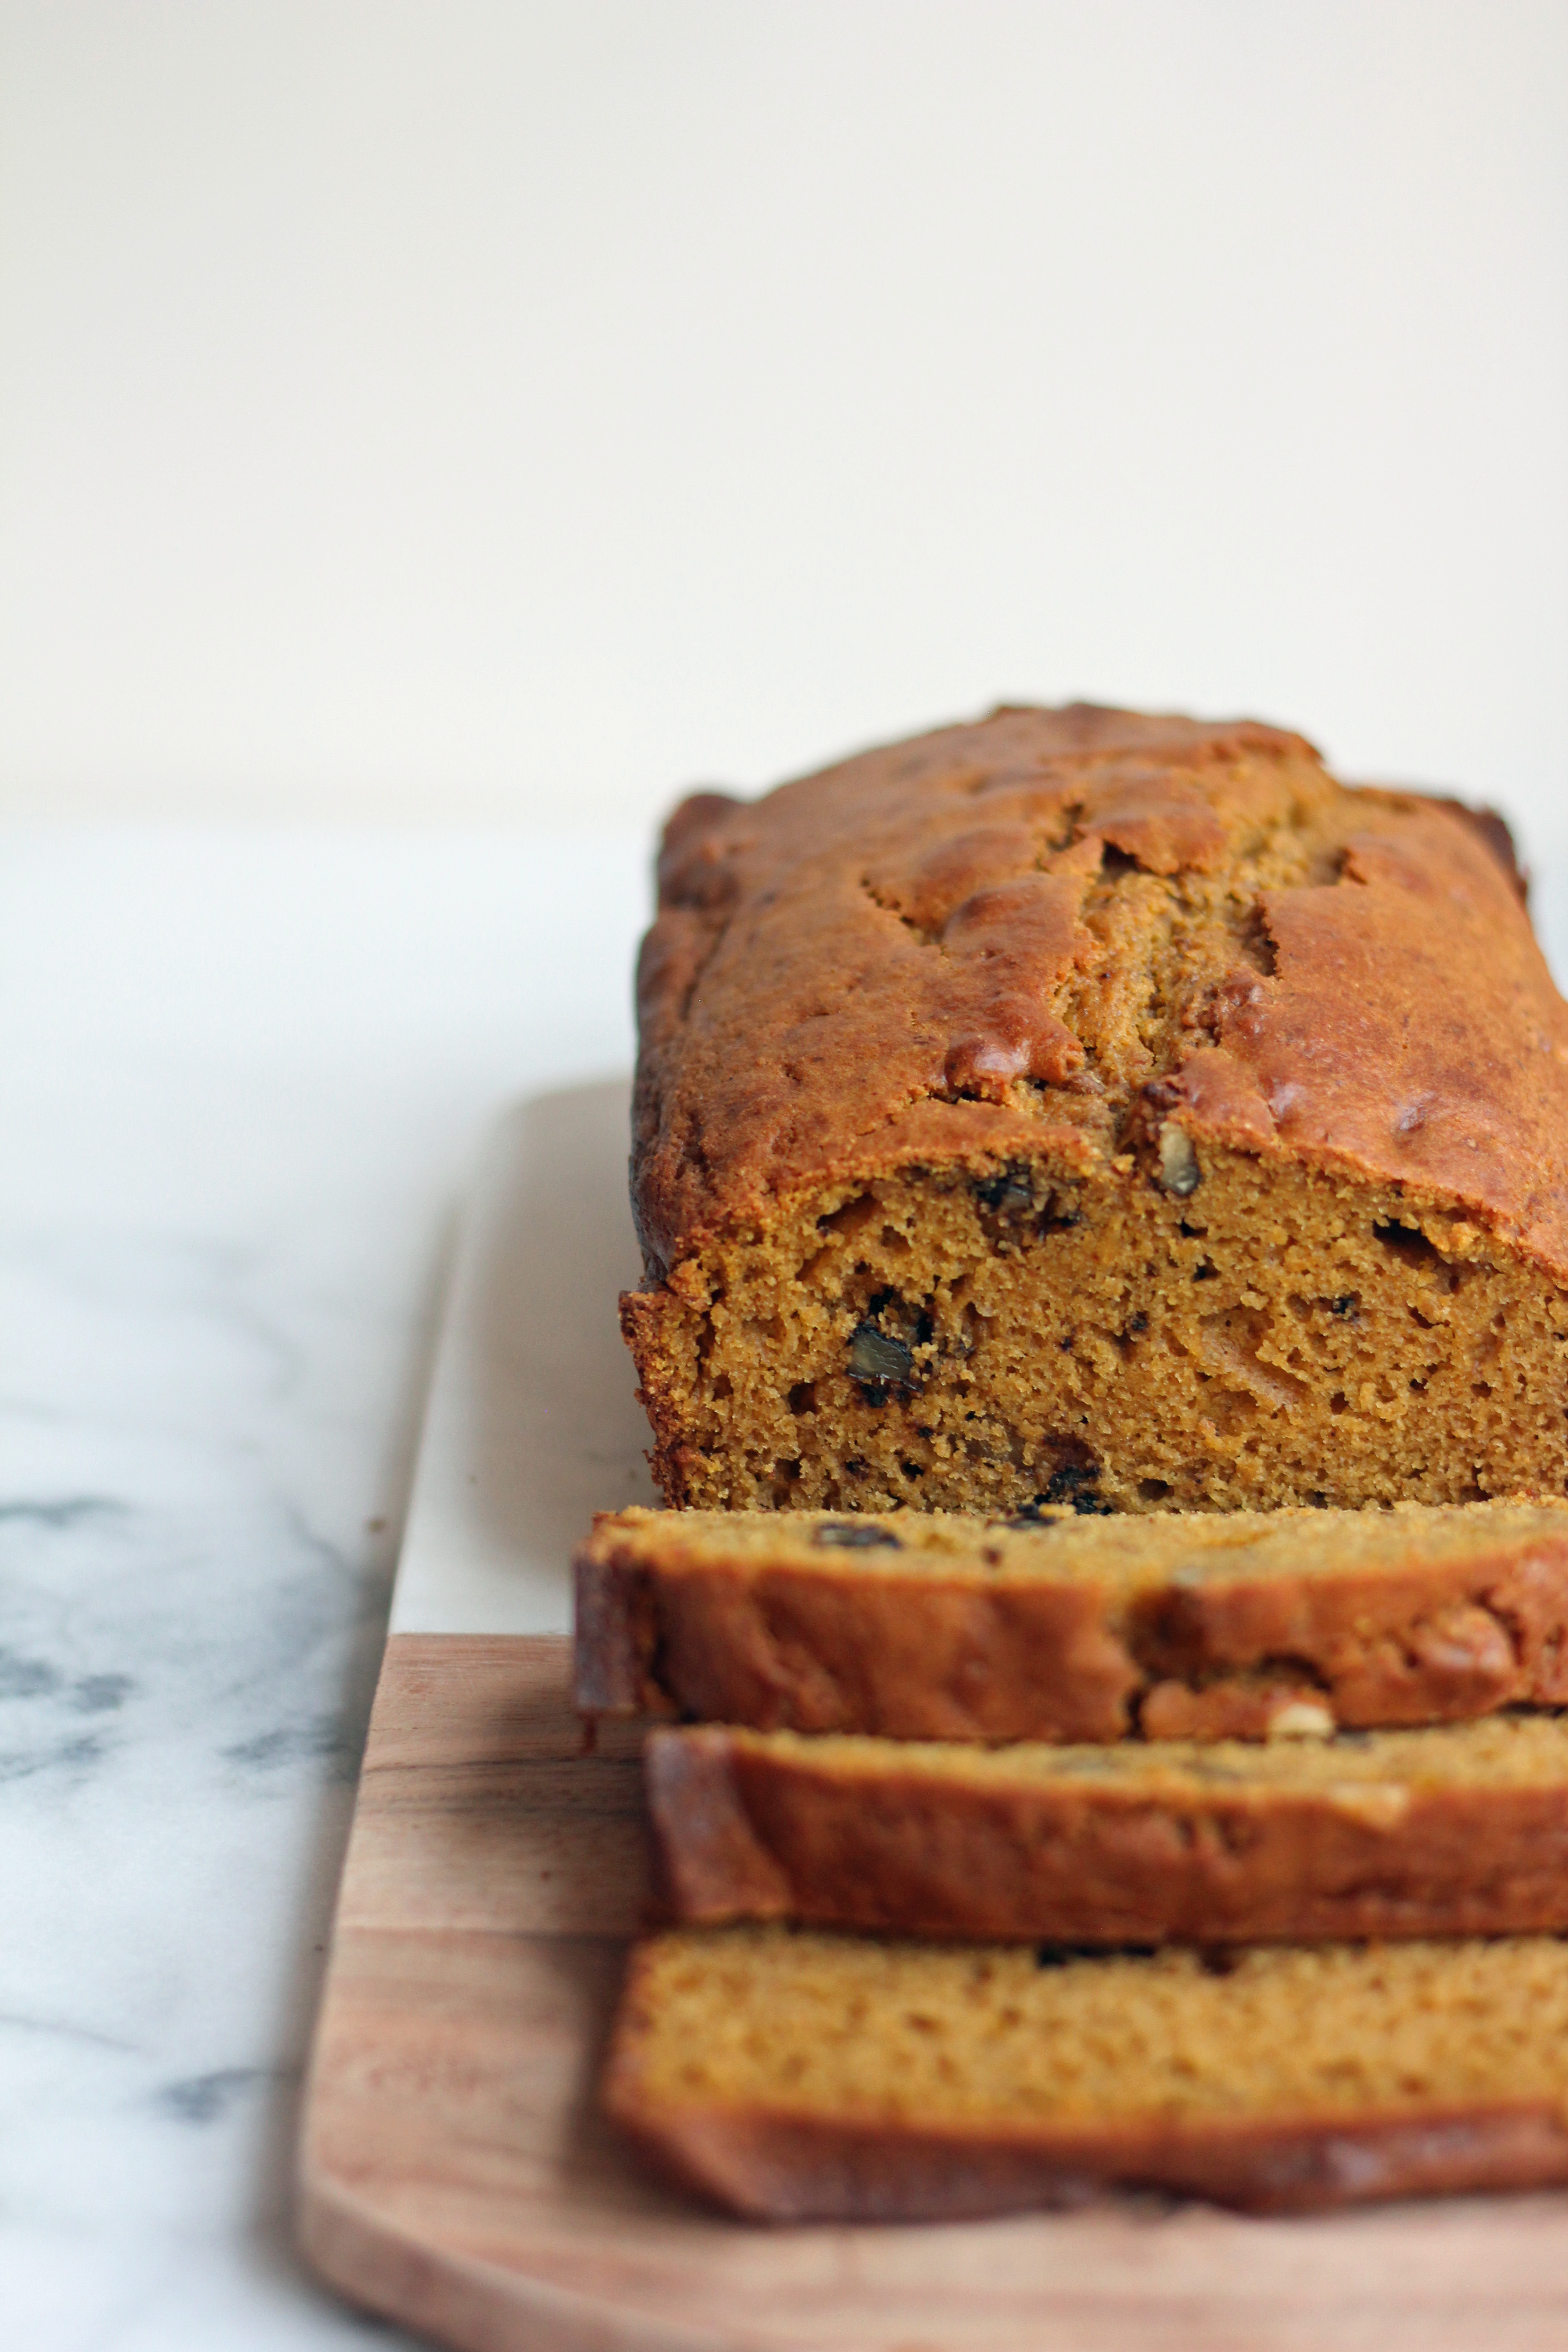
[299,1635,1568,2352]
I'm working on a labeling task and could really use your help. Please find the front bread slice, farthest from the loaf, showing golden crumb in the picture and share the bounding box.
[604,1926,1568,2220]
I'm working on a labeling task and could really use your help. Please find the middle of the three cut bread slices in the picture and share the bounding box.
[644,1715,1568,1945]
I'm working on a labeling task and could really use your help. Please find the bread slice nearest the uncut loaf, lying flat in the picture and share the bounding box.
[576,1500,1568,1740]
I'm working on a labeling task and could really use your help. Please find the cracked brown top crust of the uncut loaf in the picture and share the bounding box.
[632,703,1568,1279]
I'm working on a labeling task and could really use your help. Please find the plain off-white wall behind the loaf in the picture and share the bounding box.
[0,0,1568,854]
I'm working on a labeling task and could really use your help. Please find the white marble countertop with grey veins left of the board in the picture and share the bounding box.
[0,826,647,2352]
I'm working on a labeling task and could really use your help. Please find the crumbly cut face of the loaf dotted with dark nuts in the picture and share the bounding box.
[625,1122,1568,1512]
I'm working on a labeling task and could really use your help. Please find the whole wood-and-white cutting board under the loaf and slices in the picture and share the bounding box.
[299,1084,1568,2352]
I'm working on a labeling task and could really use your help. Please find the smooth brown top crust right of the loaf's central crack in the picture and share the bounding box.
[1152,795,1568,1282]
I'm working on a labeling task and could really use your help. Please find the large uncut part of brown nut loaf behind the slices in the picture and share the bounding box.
[623,706,1568,1512]
